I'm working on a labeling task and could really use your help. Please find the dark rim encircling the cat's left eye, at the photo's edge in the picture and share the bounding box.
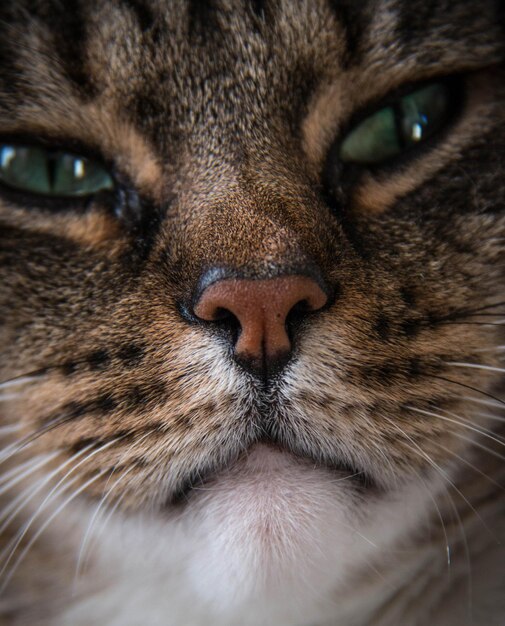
[0,133,120,213]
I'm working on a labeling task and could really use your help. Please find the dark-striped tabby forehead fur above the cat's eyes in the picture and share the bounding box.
[0,0,505,109]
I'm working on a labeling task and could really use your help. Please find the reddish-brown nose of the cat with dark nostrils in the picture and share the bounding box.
[194,276,328,376]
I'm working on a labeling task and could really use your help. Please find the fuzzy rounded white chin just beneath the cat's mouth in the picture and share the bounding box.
[179,444,368,605]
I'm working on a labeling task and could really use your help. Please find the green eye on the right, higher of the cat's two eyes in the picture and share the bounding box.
[339,83,450,165]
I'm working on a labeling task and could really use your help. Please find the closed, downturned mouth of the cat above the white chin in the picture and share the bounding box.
[167,440,379,507]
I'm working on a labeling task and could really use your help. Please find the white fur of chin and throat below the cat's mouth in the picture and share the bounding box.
[61,446,434,626]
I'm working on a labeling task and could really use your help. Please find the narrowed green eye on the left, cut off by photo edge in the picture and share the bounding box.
[0,143,114,198]
